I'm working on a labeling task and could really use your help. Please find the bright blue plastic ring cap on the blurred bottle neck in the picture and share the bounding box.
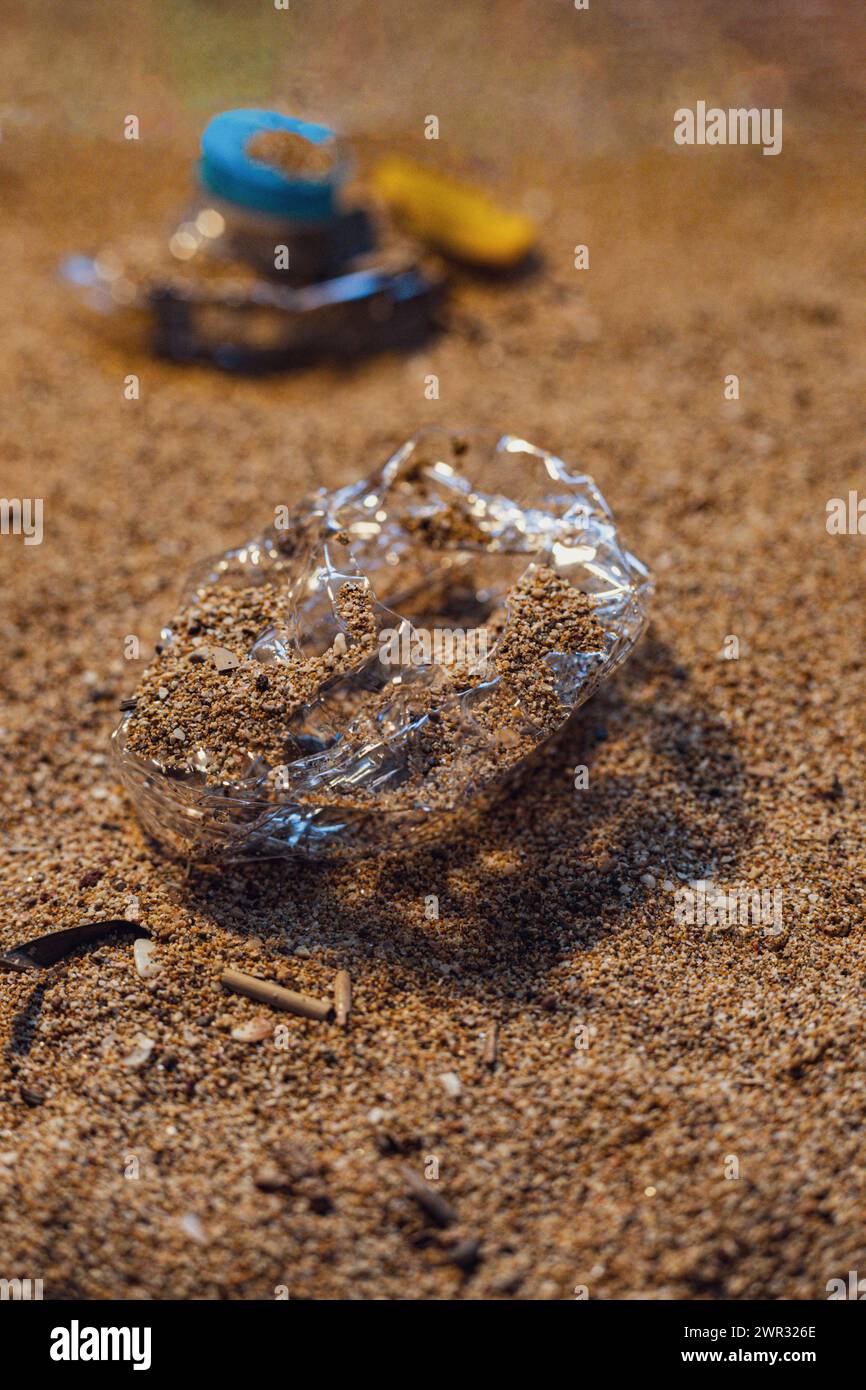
[199,108,338,222]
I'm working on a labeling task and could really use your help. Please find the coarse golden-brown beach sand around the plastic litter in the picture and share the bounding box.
[0,3,866,1300]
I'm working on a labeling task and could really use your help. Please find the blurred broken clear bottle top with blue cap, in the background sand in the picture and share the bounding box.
[61,110,443,371]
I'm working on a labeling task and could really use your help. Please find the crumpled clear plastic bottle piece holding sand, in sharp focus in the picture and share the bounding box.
[114,431,652,862]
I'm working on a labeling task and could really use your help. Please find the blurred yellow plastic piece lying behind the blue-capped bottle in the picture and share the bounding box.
[373,156,535,270]
